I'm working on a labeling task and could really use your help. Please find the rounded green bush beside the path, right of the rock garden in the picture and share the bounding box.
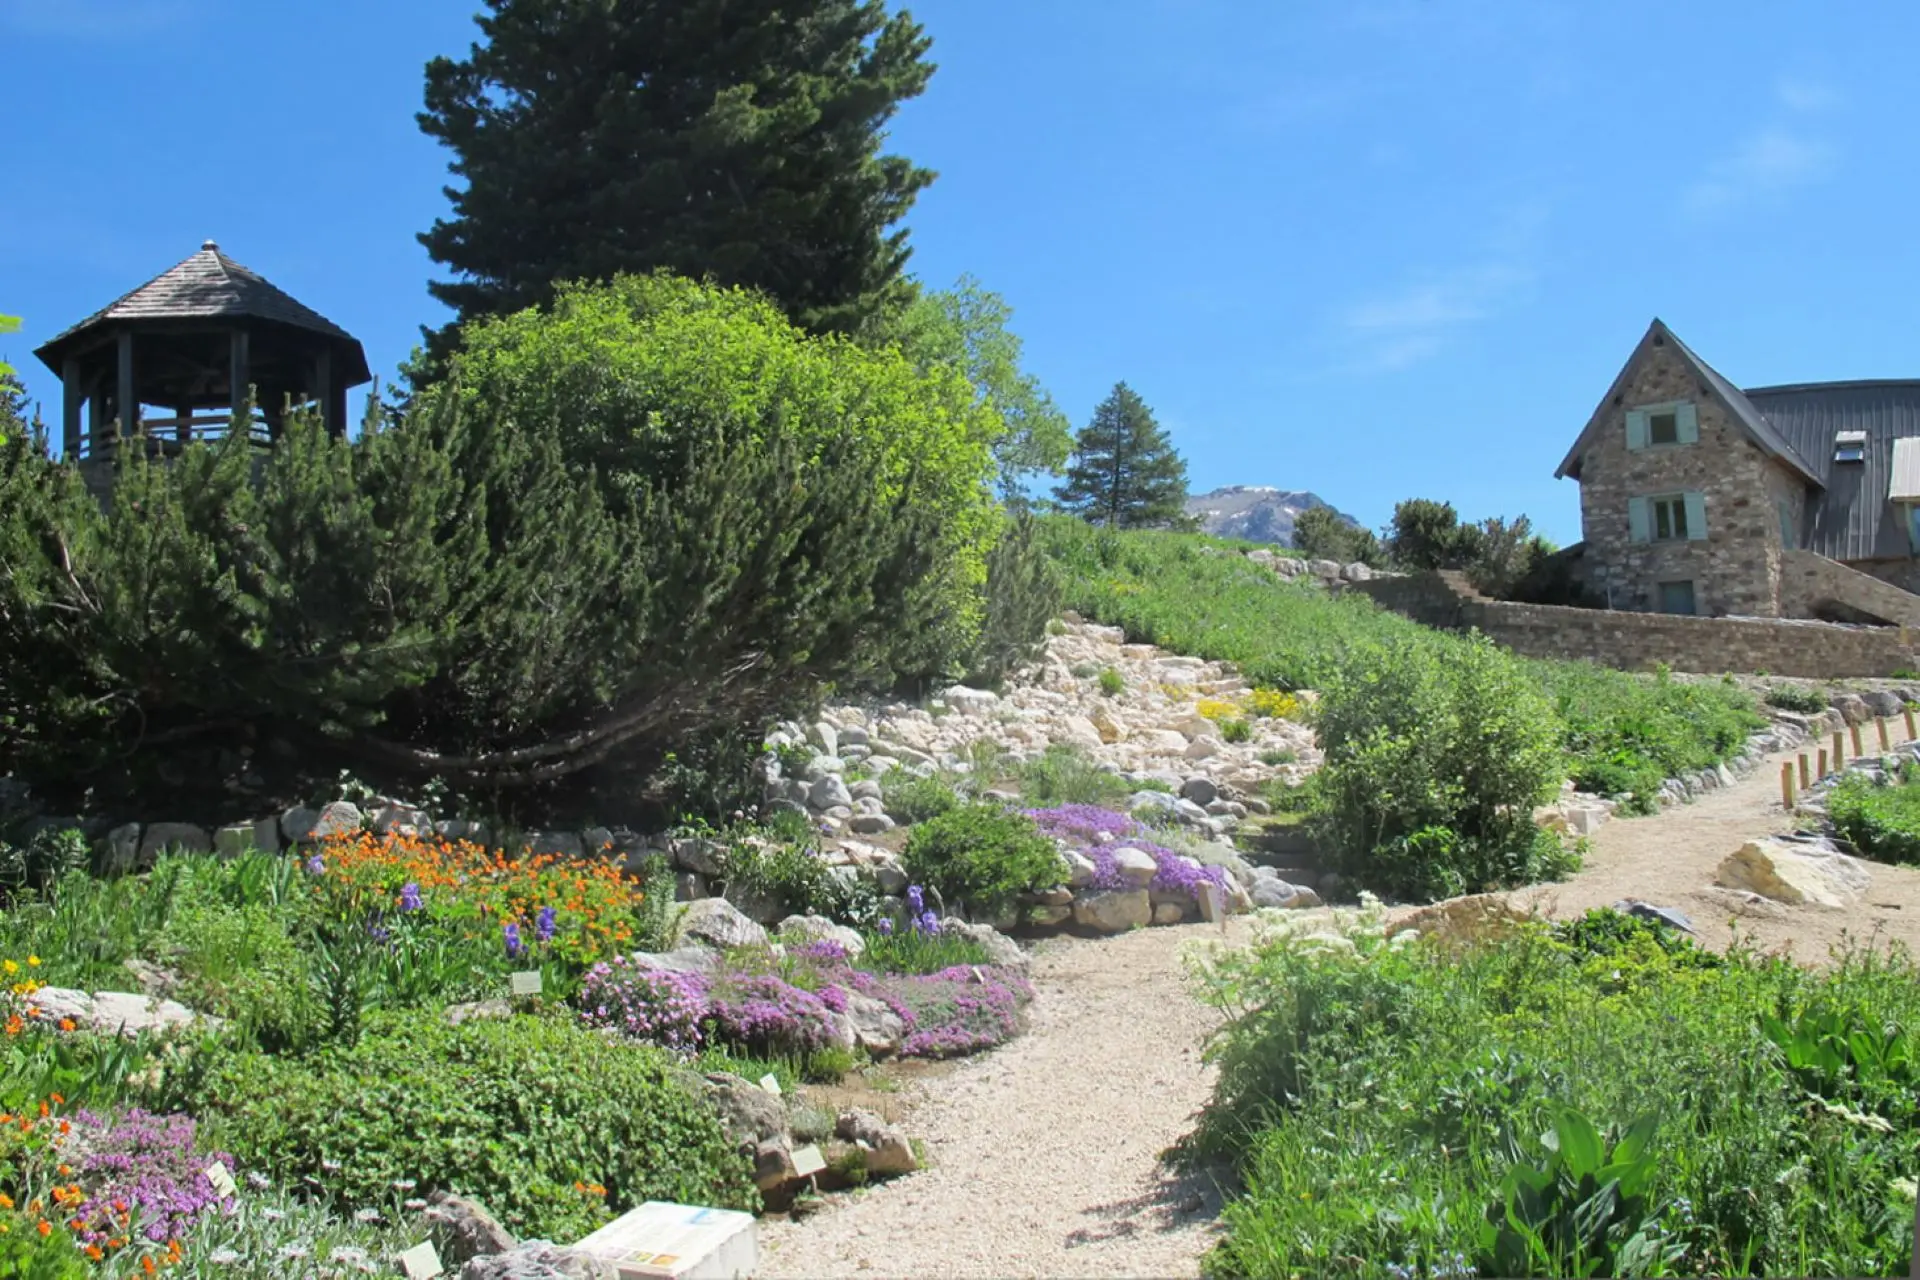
[1315,637,1569,898]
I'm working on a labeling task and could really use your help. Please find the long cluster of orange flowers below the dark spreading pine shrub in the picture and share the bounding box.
[315,833,641,963]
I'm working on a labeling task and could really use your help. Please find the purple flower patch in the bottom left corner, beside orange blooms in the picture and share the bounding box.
[73,1109,234,1244]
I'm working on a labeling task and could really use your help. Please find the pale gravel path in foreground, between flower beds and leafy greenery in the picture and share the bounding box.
[756,921,1244,1280]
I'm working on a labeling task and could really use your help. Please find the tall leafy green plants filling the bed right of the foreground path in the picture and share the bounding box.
[1188,908,1920,1280]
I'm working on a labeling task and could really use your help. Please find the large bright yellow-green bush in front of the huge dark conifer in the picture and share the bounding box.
[419,274,1006,672]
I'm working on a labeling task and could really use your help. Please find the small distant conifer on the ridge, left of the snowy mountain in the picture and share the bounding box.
[1054,382,1194,530]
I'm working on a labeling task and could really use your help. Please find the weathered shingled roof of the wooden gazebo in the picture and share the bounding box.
[35,240,372,386]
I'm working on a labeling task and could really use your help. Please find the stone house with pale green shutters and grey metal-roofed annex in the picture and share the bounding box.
[1555,320,1920,626]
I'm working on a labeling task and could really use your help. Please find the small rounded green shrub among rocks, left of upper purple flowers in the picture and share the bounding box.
[900,802,1066,915]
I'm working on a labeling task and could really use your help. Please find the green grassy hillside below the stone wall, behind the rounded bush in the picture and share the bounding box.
[1044,518,1763,798]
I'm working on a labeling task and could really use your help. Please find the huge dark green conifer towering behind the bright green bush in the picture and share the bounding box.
[419,0,933,355]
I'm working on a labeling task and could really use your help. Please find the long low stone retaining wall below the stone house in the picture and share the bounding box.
[1350,564,1920,679]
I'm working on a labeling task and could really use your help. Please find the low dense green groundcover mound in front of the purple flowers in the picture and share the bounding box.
[192,1015,755,1240]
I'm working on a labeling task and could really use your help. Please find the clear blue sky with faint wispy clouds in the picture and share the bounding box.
[0,0,1920,541]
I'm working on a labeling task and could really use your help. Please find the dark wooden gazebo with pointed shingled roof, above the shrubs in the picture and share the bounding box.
[35,240,372,461]
